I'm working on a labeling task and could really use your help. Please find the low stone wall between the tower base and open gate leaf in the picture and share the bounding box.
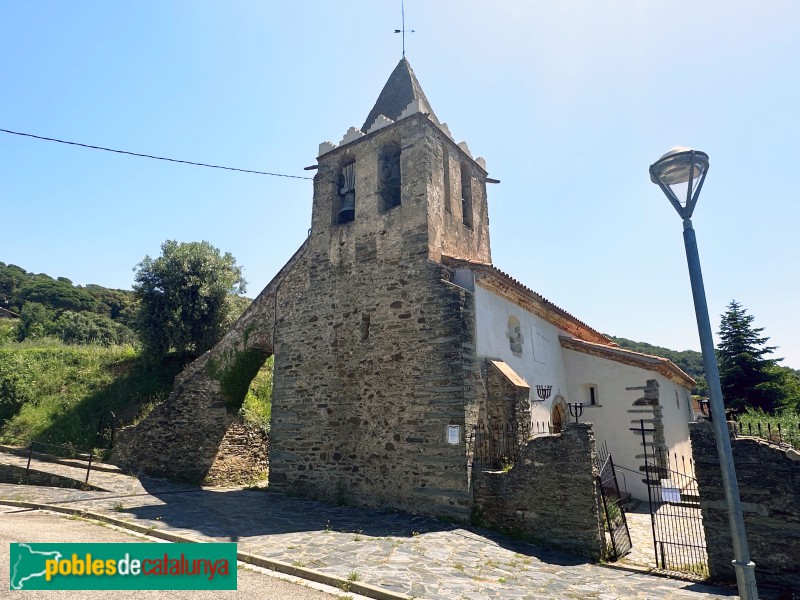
[472,423,606,560]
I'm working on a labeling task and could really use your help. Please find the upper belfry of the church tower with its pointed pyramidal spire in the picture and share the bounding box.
[311,58,493,265]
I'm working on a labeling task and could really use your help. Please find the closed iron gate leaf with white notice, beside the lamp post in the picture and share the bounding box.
[640,422,709,578]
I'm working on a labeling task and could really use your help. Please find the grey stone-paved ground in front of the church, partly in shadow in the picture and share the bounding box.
[0,453,735,600]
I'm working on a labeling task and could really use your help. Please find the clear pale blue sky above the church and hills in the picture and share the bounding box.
[0,0,800,368]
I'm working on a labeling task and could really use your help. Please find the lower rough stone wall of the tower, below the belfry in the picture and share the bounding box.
[270,259,477,518]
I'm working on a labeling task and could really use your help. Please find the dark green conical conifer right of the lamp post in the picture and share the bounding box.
[717,300,783,412]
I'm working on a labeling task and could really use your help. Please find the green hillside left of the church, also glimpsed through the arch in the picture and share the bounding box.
[0,262,272,450]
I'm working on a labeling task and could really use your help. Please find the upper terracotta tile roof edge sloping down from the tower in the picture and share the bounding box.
[442,255,616,346]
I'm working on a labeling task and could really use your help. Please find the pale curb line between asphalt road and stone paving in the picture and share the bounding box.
[0,499,412,600]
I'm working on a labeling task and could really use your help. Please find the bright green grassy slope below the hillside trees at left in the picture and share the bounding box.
[0,339,181,450]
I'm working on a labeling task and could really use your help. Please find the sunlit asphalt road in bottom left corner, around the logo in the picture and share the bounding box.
[0,506,358,600]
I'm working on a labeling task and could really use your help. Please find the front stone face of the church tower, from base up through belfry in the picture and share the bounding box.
[270,116,482,519]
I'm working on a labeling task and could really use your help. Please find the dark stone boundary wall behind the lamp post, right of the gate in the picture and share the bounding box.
[689,422,800,593]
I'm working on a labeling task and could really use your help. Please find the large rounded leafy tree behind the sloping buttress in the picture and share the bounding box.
[133,240,246,360]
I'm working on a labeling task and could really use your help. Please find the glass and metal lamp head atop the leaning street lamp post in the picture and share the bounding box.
[650,146,708,219]
